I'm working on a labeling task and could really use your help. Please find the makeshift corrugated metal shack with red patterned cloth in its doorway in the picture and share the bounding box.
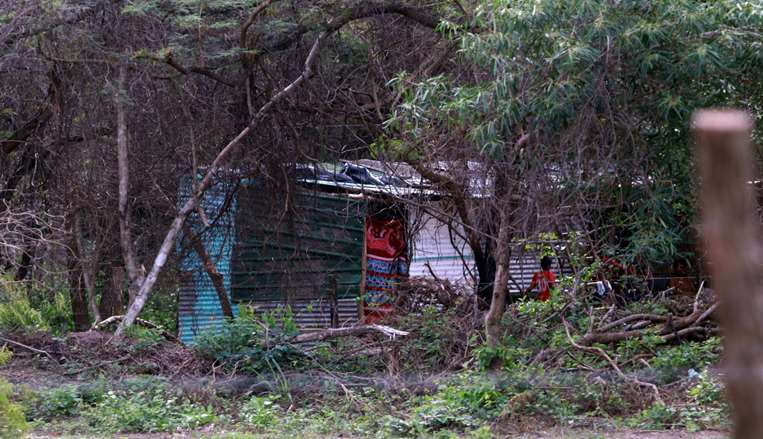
[178,161,568,344]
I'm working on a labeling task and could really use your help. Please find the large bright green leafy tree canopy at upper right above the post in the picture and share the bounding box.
[396,0,763,263]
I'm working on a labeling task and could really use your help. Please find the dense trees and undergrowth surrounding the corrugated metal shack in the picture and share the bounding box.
[0,0,763,437]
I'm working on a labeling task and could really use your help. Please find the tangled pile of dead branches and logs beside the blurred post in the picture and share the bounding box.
[511,287,720,401]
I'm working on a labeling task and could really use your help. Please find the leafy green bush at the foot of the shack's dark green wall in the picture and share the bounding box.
[196,308,299,373]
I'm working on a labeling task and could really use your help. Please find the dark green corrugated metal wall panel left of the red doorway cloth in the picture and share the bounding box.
[232,187,366,303]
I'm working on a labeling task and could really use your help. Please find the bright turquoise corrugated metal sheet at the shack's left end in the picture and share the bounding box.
[178,178,238,344]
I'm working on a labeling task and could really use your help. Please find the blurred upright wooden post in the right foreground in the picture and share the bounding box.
[693,110,763,439]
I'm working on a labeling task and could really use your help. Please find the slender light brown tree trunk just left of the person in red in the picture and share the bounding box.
[485,209,510,346]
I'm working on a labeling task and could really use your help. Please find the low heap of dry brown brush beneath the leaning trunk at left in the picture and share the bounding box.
[0,330,212,377]
